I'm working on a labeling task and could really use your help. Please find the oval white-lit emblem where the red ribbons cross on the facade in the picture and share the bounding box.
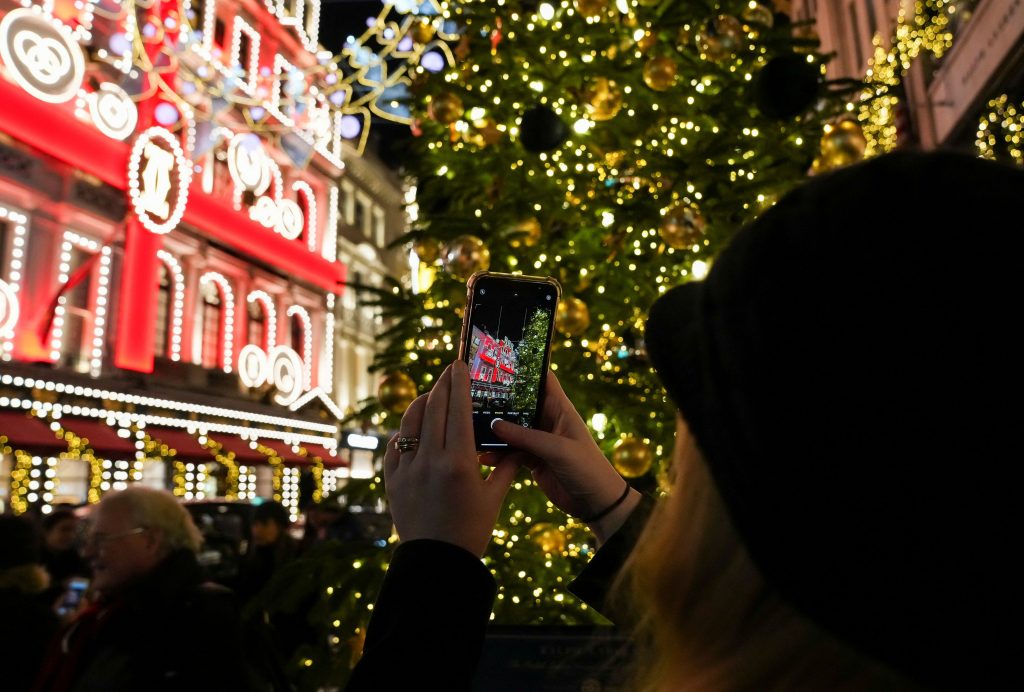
[128,127,191,233]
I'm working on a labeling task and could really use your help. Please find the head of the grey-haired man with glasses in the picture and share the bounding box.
[83,485,202,597]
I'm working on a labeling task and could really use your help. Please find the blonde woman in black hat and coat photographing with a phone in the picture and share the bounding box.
[349,154,1024,691]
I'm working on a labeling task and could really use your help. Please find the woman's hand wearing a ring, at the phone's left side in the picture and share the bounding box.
[384,360,518,557]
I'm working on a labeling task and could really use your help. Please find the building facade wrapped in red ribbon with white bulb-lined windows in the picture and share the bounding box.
[0,0,400,512]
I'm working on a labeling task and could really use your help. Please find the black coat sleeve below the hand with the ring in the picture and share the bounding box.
[345,539,498,692]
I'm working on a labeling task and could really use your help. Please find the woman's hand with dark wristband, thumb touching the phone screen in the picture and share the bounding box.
[494,372,640,543]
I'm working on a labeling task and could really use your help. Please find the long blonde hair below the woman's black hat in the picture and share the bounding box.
[616,420,915,692]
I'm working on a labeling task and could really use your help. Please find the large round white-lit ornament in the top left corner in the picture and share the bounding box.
[0,7,85,103]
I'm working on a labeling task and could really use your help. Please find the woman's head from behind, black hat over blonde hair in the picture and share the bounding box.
[624,154,1024,690]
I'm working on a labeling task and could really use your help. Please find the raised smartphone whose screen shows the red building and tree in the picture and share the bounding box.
[459,271,562,451]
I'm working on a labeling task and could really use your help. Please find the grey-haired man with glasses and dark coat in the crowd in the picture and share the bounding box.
[36,486,250,692]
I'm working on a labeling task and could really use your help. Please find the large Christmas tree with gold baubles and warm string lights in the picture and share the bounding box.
[288,0,864,679]
